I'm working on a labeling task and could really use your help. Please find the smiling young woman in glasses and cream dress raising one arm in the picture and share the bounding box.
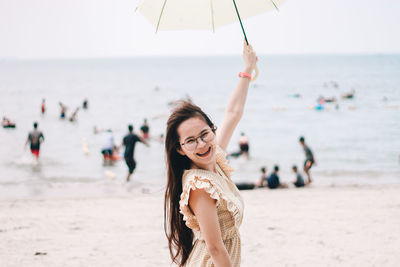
[164,40,257,267]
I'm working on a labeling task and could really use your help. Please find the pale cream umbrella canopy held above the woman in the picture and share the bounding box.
[136,0,284,32]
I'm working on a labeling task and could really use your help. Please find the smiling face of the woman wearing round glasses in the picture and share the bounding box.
[177,117,216,169]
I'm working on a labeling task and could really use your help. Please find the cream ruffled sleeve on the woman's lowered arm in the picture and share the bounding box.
[179,172,222,230]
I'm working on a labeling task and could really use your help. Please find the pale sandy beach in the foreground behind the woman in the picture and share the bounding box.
[0,185,400,267]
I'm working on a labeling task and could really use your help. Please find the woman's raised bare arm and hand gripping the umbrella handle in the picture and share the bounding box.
[217,41,257,150]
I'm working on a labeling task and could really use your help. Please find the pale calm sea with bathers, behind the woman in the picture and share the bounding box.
[0,55,400,199]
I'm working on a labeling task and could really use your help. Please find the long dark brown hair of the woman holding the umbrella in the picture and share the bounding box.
[164,101,214,267]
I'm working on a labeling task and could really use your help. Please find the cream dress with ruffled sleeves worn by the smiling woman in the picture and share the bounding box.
[179,146,244,267]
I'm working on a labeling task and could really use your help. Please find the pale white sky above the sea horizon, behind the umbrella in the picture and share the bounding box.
[0,0,400,59]
